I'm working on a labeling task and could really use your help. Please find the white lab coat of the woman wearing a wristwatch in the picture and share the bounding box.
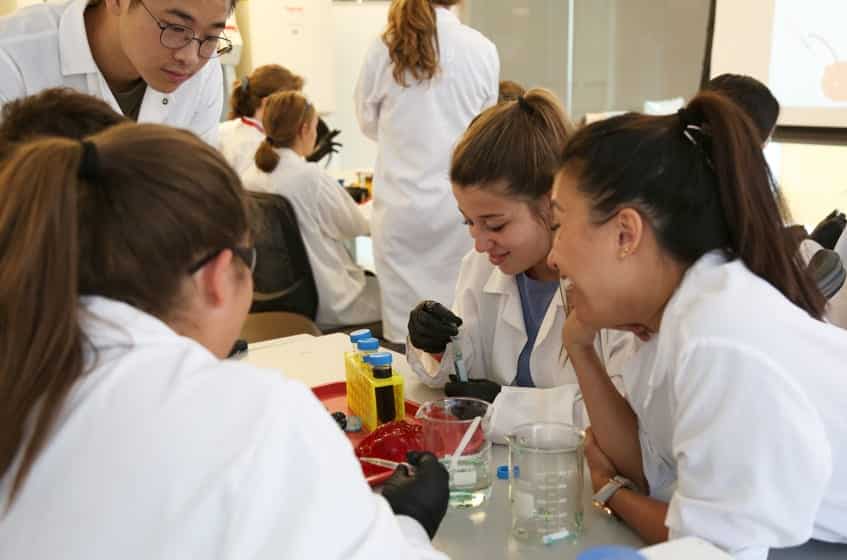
[624,252,847,560]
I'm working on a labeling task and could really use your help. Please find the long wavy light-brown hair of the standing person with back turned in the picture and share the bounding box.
[382,0,459,87]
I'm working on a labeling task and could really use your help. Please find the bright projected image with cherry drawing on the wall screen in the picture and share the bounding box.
[769,0,847,108]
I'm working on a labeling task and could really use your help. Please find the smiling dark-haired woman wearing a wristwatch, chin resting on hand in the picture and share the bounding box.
[550,92,847,560]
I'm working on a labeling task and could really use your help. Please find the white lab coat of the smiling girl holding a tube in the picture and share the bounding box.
[406,251,637,442]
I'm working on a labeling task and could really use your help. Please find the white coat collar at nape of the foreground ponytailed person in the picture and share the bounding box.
[80,296,184,349]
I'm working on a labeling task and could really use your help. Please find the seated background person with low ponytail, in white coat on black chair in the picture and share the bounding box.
[242,92,380,328]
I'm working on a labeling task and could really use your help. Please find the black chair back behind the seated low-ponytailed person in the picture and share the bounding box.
[248,192,318,321]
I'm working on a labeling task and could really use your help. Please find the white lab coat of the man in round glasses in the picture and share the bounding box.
[0,0,223,146]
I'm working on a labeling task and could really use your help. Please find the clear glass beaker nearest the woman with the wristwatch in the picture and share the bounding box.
[506,422,585,544]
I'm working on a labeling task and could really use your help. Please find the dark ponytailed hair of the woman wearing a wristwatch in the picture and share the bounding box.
[560,92,825,318]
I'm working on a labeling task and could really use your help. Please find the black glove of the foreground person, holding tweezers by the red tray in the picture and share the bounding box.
[382,451,450,539]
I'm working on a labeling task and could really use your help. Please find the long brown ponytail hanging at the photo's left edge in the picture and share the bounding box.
[0,139,83,503]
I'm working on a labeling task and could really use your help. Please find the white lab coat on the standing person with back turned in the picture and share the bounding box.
[355,7,500,342]
